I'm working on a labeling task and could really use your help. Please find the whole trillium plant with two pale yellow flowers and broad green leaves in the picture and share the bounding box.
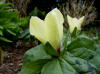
[19,8,100,74]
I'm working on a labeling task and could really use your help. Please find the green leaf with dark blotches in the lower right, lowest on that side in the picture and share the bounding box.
[64,55,96,74]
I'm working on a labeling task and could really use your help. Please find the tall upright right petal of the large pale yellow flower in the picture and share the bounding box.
[45,8,64,49]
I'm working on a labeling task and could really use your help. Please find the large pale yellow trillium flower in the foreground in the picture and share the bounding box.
[30,8,64,50]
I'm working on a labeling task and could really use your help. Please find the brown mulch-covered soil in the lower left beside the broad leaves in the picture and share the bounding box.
[0,40,36,74]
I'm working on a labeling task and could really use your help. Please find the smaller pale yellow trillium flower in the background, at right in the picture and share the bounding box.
[67,15,84,33]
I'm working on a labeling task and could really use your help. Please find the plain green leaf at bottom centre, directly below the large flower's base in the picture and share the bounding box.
[41,59,63,74]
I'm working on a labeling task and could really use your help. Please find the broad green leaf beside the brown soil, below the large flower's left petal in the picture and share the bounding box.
[21,44,51,74]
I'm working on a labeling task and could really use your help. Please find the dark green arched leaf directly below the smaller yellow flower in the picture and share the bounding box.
[68,37,95,51]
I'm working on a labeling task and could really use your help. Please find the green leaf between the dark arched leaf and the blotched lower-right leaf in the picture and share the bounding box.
[69,48,97,60]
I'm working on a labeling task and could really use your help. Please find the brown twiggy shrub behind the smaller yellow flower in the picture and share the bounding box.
[60,0,96,26]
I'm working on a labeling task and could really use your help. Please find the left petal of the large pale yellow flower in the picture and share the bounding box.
[30,16,47,44]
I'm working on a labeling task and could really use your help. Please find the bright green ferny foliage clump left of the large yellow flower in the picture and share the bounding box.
[0,3,27,43]
